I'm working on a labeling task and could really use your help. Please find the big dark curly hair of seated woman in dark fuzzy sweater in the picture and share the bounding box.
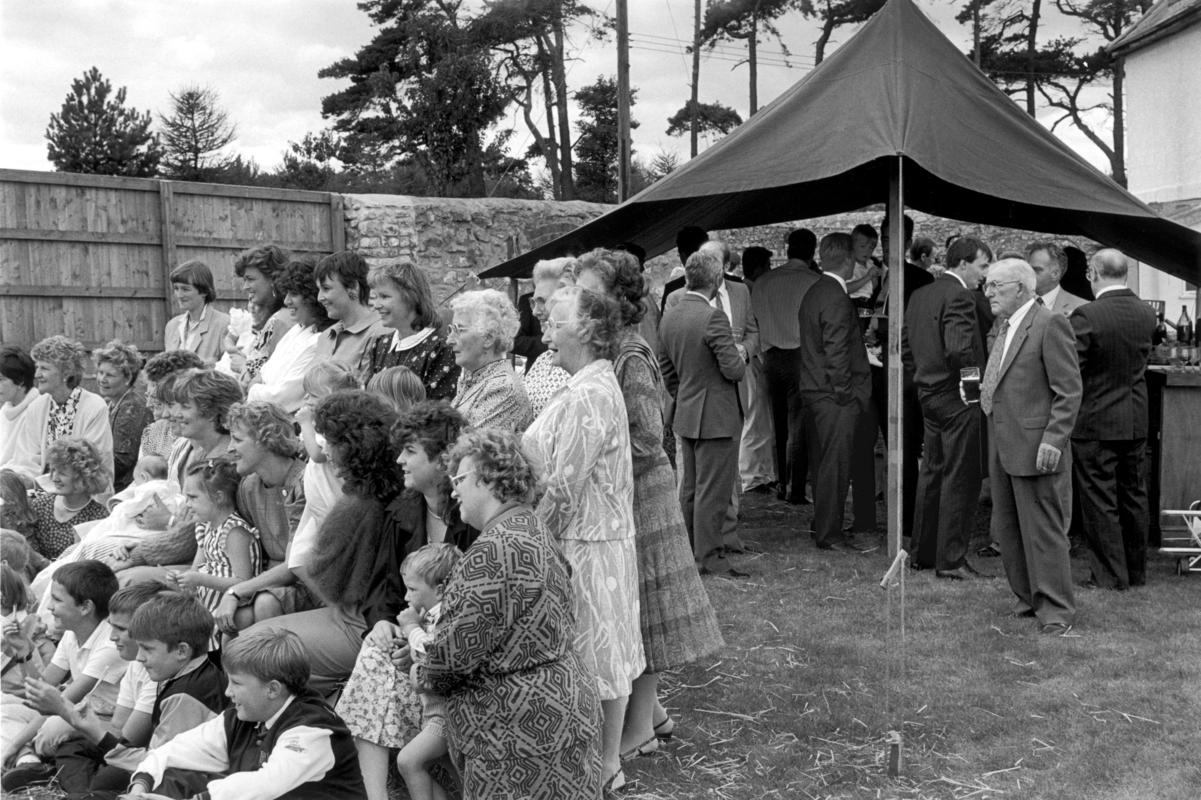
[313,389,404,503]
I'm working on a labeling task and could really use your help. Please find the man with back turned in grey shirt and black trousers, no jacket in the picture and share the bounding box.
[751,228,819,503]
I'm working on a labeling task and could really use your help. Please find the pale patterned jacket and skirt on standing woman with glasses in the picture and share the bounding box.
[524,359,646,700]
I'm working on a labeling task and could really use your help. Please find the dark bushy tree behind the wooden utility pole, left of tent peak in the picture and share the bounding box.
[575,76,638,203]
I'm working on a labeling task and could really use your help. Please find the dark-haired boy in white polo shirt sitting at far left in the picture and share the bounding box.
[0,561,125,777]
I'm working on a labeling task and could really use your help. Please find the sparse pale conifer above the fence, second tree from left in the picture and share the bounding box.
[159,86,236,180]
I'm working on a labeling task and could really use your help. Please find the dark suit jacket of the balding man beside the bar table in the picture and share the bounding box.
[1071,288,1155,440]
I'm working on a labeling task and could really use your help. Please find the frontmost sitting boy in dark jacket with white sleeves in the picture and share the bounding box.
[125,629,365,800]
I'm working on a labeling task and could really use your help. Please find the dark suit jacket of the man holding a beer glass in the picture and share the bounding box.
[901,274,987,401]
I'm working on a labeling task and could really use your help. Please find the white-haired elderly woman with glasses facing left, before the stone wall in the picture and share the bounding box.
[447,289,533,434]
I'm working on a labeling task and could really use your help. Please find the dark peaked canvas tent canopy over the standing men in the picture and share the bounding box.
[482,0,1201,282]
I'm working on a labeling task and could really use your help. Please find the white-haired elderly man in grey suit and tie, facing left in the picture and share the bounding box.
[980,258,1081,635]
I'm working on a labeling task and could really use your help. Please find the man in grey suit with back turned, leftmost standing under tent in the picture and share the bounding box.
[659,251,747,578]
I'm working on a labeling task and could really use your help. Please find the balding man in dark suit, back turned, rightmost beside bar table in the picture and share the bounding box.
[1069,250,1155,589]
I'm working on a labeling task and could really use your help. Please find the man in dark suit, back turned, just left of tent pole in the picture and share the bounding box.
[799,233,876,553]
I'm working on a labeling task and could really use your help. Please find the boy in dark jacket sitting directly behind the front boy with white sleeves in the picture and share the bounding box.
[12,584,227,798]
